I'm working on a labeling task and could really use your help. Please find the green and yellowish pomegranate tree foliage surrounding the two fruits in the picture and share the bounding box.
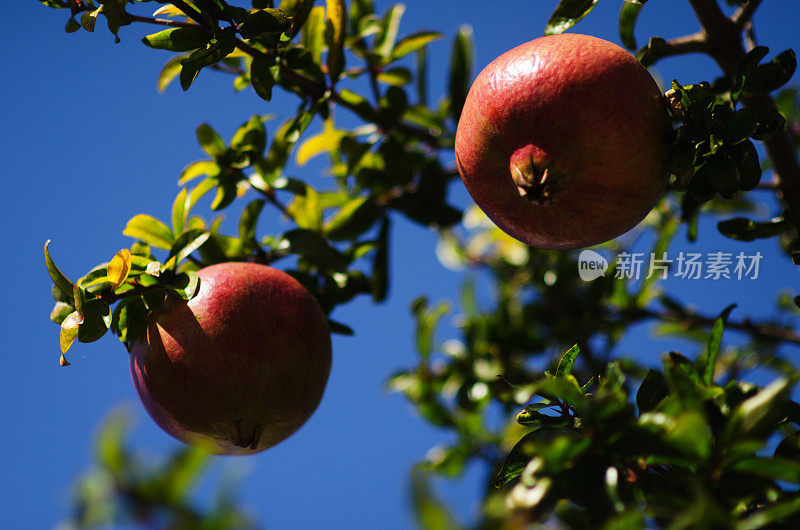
[40,0,800,528]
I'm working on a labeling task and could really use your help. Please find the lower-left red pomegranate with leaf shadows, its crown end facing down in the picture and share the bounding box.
[130,263,331,454]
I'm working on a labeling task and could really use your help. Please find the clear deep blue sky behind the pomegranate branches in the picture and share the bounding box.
[0,0,800,529]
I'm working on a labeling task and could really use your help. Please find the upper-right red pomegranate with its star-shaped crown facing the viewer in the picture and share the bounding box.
[455,34,671,249]
